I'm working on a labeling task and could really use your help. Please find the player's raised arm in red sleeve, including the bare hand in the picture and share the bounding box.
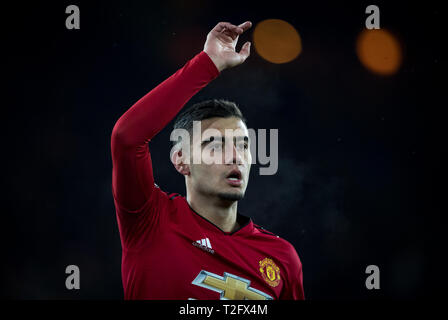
[111,22,251,213]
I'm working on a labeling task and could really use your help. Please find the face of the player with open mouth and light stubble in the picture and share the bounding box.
[189,117,252,201]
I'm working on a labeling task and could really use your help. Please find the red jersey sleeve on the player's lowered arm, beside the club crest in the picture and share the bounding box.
[280,244,305,300]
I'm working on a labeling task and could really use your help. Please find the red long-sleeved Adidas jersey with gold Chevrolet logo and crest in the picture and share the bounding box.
[111,51,304,300]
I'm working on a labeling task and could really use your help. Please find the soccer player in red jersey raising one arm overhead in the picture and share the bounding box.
[111,21,304,300]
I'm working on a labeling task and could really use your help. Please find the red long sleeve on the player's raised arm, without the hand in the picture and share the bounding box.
[111,51,219,245]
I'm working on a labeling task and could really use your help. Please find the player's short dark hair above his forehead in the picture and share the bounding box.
[173,99,246,144]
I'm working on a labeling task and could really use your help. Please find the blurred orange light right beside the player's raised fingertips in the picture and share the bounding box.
[253,19,302,63]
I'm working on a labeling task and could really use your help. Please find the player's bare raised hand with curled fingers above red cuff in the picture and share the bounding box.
[204,21,252,72]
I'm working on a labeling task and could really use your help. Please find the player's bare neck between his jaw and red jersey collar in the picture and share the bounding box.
[187,193,239,232]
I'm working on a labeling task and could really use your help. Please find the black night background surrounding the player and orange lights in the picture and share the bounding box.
[0,1,440,300]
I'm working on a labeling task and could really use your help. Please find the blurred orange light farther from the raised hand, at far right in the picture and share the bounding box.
[356,29,402,75]
